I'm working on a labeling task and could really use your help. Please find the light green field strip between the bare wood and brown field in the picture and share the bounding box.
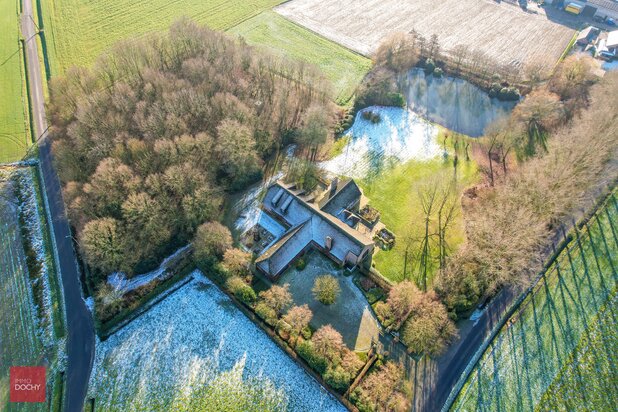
[229,11,371,104]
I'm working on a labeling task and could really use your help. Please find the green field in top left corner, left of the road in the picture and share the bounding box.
[0,0,29,163]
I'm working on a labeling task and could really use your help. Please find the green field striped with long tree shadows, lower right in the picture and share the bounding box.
[452,196,618,411]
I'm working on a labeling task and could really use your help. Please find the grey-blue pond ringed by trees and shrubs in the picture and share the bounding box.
[403,69,517,137]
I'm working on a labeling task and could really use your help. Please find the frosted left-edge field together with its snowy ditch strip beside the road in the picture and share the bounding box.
[0,168,57,410]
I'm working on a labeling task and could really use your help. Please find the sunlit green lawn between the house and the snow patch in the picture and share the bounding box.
[359,142,478,284]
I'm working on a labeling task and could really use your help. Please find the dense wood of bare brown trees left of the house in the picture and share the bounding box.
[49,20,333,283]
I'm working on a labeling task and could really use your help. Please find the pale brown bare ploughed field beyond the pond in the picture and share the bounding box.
[275,0,574,65]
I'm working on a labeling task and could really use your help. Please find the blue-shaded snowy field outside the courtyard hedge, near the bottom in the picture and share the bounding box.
[88,271,345,411]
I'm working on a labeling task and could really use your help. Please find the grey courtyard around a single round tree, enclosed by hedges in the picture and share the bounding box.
[278,250,380,352]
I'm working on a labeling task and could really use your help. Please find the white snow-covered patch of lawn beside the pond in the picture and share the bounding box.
[320,106,442,179]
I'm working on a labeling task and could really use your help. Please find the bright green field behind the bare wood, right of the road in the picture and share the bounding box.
[40,0,281,76]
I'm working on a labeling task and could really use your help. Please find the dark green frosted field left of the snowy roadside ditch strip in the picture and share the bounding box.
[0,171,45,410]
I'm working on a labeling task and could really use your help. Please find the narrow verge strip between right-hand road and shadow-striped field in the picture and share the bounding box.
[441,182,616,412]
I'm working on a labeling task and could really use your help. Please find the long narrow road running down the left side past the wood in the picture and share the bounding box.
[22,0,94,412]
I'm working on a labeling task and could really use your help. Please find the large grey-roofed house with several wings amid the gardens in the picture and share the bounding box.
[255,179,377,278]
